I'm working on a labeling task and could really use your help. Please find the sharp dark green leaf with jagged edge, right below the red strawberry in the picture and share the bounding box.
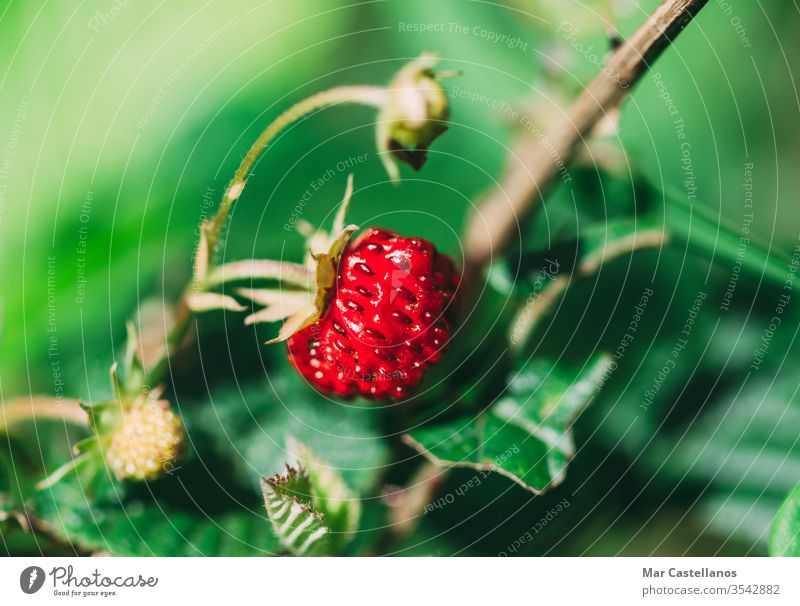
[403,355,611,493]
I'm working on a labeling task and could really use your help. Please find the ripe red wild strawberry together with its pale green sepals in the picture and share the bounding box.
[225,180,459,400]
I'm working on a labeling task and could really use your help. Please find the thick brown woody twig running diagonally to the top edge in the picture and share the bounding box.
[465,0,708,280]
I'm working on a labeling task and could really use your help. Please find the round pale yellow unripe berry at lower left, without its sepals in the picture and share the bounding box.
[106,399,183,481]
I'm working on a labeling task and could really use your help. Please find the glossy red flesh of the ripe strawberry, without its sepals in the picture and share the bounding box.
[288,228,459,400]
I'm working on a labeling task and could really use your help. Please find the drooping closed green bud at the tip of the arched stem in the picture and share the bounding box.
[377,53,450,181]
